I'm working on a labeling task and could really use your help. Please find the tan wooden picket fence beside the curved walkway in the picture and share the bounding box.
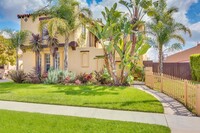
[145,67,200,116]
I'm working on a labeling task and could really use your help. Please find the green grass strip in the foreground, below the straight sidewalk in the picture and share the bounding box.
[0,110,170,133]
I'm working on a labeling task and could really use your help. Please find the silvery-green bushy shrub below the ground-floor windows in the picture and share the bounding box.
[44,69,76,84]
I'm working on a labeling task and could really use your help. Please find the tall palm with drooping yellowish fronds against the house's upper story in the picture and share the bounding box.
[33,0,91,70]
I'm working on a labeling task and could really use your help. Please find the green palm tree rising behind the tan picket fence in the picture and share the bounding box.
[147,0,191,73]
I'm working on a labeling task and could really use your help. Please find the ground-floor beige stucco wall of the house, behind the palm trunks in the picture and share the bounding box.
[23,47,104,74]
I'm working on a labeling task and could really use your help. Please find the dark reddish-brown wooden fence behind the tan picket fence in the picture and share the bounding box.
[143,61,192,80]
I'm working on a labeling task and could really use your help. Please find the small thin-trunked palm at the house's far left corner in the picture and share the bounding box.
[6,30,28,72]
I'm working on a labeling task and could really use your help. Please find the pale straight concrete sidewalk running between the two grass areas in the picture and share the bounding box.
[0,101,200,133]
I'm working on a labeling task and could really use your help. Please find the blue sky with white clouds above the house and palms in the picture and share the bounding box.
[0,0,200,59]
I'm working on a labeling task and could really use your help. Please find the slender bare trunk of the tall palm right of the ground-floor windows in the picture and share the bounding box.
[64,35,69,70]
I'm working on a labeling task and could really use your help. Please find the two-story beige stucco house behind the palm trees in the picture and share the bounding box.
[18,14,104,74]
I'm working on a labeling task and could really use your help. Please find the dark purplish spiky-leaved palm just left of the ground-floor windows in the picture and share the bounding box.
[30,33,42,76]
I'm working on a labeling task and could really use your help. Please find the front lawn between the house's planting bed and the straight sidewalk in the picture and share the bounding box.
[0,83,163,113]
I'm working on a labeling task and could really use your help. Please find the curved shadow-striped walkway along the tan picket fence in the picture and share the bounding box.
[134,85,195,116]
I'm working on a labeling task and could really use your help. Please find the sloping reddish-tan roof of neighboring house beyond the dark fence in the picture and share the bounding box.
[164,43,200,63]
